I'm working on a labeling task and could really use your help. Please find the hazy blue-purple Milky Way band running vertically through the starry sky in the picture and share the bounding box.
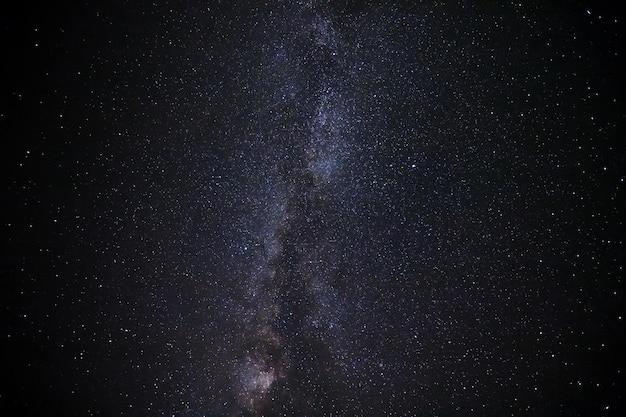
[227,5,355,412]
